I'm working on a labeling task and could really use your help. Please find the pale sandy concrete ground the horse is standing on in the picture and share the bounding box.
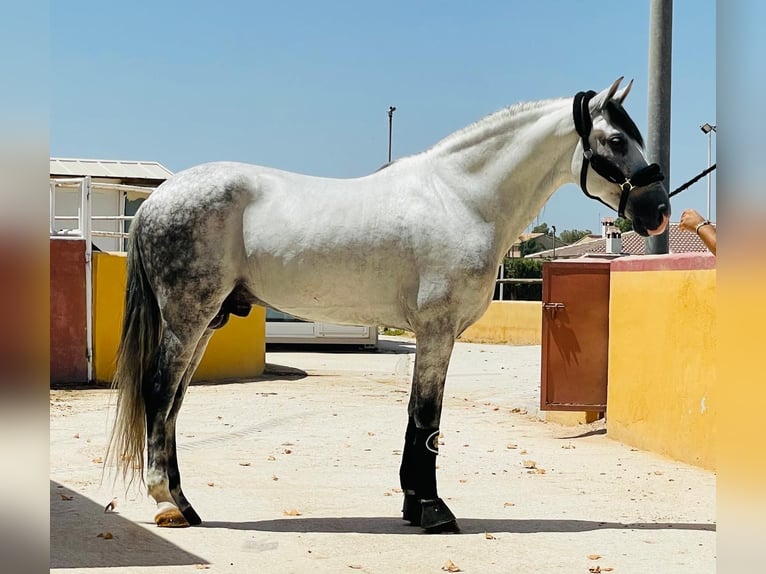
[50,337,716,574]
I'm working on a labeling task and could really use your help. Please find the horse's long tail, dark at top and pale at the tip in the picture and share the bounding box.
[105,227,162,486]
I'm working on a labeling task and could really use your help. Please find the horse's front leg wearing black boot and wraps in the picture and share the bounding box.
[399,330,459,532]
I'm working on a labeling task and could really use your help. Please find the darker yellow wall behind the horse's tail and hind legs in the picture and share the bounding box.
[93,252,266,382]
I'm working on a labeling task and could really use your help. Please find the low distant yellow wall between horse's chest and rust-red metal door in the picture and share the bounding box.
[460,301,543,345]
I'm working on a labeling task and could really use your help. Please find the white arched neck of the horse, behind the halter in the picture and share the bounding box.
[429,99,577,249]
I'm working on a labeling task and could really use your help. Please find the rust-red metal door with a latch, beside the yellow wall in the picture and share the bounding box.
[540,260,609,412]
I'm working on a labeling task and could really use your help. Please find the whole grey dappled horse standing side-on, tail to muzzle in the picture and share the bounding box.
[107,78,670,532]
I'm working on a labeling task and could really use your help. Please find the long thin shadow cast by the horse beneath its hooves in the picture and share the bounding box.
[202,516,716,534]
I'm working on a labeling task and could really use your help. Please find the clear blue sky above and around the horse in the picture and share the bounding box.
[50,0,716,231]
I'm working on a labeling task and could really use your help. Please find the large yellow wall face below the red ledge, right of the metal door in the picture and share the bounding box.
[607,268,717,469]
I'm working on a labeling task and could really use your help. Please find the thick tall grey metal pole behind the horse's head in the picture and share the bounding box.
[644,0,673,254]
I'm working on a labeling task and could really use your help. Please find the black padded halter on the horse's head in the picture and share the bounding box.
[572,90,665,218]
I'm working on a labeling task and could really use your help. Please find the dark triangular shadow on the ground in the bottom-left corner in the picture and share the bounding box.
[50,481,208,571]
